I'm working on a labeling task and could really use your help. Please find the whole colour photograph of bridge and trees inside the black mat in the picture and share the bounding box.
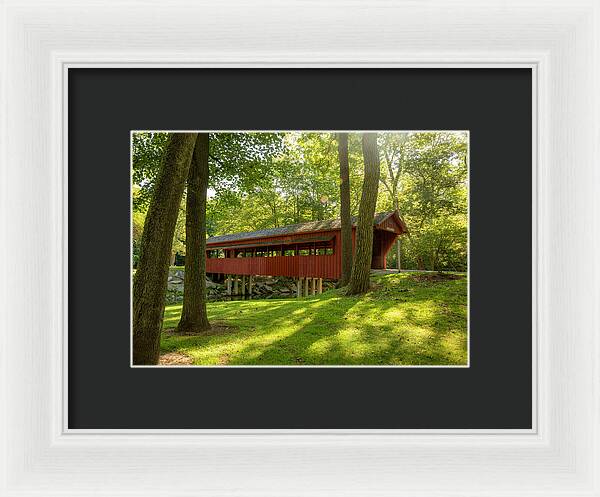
[130,130,470,367]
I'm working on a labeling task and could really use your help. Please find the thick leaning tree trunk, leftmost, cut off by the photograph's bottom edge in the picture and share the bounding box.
[132,133,197,364]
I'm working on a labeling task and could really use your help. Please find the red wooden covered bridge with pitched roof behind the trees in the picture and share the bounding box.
[206,211,407,293]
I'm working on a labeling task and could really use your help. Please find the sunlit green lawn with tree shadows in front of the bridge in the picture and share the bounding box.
[161,273,467,365]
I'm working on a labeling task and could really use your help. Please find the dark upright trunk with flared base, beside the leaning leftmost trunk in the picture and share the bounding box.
[177,133,210,333]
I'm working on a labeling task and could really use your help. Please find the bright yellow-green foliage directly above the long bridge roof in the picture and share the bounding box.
[207,133,362,235]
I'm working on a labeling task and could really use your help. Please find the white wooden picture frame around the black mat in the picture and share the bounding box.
[0,0,600,497]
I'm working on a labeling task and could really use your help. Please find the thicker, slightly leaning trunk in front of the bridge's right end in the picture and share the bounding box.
[346,133,380,295]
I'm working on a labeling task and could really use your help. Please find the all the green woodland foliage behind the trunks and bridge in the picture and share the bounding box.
[133,132,468,271]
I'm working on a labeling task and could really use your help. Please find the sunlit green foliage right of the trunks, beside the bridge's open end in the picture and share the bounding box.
[378,132,468,271]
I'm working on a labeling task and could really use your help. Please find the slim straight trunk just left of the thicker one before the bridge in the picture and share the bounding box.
[338,133,352,286]
